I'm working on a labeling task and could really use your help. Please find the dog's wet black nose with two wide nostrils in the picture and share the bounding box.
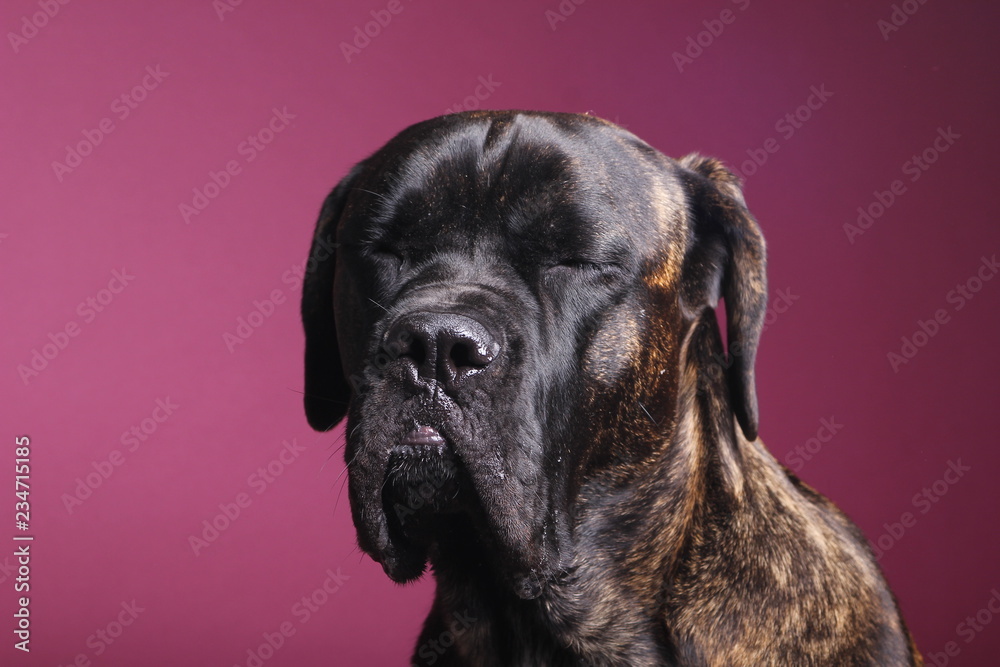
[385,312,500,385]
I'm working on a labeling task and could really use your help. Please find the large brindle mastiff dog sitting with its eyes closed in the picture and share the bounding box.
[302,111,922,667]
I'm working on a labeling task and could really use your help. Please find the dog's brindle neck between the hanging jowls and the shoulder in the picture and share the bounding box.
[417,316,757,665]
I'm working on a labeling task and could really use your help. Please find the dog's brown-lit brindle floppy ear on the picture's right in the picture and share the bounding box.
[679,154,767,441]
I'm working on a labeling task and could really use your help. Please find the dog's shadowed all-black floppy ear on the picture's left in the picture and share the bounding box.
[302,165,361,431]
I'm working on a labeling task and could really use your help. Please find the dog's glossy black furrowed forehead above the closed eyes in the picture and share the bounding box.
[344,112,687,262]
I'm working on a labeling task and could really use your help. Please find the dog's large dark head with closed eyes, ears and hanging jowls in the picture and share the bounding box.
[302,111,766,598]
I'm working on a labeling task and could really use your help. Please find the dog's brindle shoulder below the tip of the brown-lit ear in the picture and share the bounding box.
[663,440,912,665]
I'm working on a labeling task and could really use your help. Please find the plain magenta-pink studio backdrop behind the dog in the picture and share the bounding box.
[0,0,1000,667]
